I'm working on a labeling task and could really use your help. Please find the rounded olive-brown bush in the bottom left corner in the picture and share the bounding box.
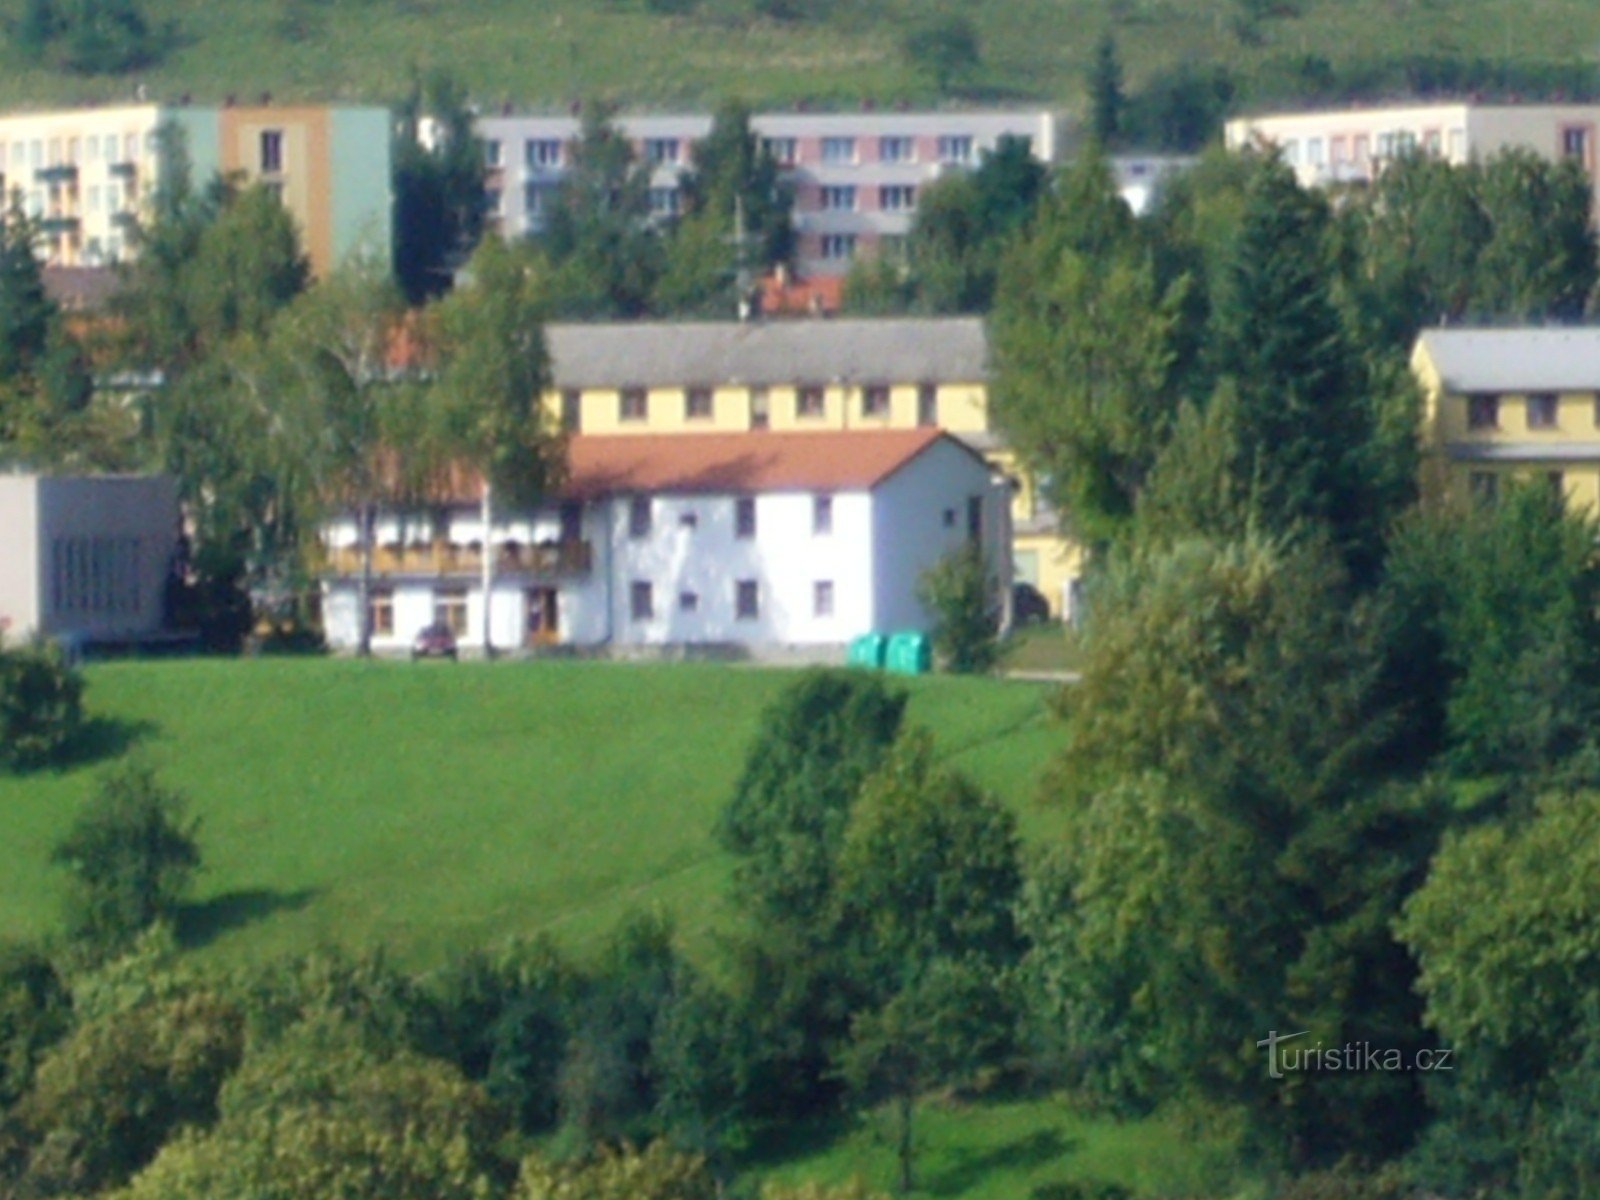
[18,987,243,1195]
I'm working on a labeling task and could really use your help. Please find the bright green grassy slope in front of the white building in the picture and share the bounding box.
[0,659,1075,963]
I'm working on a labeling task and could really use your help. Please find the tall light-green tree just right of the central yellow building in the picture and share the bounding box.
[990,155,1187,542]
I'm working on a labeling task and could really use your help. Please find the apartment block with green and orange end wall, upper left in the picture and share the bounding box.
[0,104,394,275]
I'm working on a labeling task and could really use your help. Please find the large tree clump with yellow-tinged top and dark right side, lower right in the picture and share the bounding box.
[1030,539,1442,1155]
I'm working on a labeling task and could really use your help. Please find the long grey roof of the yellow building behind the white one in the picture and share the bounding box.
[546,317,989,387]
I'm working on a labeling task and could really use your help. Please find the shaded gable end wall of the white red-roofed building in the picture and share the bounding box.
[870,442,1011,634]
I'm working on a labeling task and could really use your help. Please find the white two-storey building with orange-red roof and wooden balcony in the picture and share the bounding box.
[323,429,1011,651]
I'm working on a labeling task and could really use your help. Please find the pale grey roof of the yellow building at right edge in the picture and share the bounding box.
[1418,328,1600,392]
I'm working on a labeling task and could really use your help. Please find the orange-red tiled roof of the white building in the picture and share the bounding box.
[562,429,960,499]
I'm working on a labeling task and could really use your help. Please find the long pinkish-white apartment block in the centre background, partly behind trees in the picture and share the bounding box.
[477,110,1061,275]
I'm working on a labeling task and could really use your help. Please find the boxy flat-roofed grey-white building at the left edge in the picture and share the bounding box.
[0,475,178,642]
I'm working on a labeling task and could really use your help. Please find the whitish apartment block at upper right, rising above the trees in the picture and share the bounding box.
[1224,102,1600,206]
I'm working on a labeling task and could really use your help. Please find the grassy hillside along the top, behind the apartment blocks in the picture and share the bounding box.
[0,0,1600,116]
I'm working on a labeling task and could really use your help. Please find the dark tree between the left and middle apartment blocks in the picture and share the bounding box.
[394,72,485,304]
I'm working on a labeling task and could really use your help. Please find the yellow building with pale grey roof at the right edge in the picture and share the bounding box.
[1411,328,1600,512]
